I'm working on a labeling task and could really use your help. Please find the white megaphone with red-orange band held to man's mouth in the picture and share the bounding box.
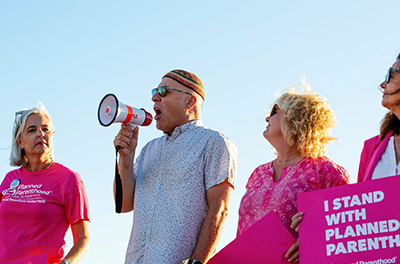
[97,94,153,126]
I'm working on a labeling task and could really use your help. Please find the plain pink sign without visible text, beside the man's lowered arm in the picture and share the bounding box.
[207,213,296,264]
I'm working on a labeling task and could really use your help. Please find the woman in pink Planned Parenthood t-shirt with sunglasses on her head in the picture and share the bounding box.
[0,103,89,264]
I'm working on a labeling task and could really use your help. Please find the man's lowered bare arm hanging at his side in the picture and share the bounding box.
[191,179,233,263]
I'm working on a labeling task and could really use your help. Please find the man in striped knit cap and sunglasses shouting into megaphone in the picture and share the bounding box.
[114,70,238,264]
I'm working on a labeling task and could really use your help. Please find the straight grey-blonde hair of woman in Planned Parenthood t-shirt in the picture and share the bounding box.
[10,102,54,166]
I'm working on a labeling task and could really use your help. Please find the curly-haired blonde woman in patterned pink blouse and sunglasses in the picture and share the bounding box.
[237,84,349,262]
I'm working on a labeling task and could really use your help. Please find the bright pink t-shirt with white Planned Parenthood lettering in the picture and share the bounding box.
[0,163,89,264]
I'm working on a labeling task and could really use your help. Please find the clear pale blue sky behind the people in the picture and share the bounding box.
[0,0,400,264]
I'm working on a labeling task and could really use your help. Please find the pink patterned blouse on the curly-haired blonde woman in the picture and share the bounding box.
[237,157,349,239]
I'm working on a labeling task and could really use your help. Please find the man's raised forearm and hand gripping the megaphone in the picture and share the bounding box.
[114,124,139,213]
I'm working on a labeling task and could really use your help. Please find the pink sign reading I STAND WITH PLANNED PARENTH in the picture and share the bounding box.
[297,176,400,264]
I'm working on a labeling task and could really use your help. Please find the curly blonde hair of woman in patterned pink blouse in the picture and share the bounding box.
[276,81,337,158]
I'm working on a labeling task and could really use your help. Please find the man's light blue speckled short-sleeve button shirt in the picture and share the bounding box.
[125,120,237,264]
